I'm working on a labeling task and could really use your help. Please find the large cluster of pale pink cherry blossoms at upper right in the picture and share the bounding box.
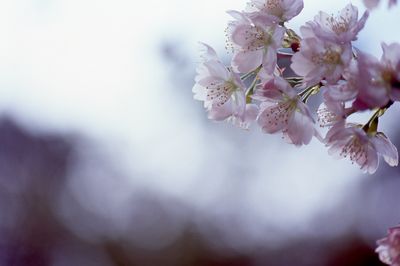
[193,0,400,173]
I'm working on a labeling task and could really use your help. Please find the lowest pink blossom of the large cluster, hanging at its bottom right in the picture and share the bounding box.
[325,121,398,174]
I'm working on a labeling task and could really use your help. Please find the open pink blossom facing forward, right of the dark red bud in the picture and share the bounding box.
[290,35,352,86]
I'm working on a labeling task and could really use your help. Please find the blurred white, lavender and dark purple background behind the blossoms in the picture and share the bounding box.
[0,0,400,266]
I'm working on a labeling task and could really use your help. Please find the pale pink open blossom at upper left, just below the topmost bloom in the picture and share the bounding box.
[228,11,285,73]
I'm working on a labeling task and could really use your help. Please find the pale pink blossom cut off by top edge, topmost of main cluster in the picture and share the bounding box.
[246,0,304,23]
